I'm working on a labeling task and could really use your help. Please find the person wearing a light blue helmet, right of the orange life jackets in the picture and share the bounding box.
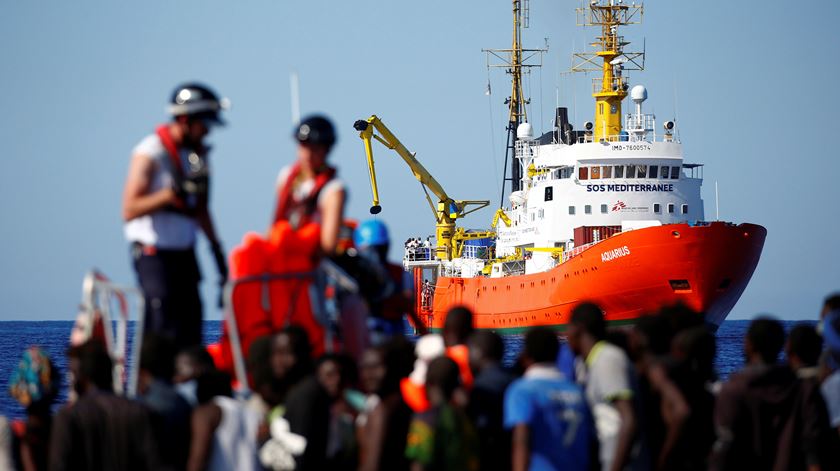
[353,219,426,345]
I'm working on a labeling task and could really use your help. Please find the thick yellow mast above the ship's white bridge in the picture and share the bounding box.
[572,0,645,142]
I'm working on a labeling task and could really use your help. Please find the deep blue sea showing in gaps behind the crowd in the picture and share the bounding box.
[0,321,794,418]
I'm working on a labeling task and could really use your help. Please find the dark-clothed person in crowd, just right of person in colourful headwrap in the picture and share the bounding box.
[49,341,160,471]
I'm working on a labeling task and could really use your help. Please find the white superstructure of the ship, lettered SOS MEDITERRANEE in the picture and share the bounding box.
[496,86,704,273]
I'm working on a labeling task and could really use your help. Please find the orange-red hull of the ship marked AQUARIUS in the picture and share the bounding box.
[420,222,767,333]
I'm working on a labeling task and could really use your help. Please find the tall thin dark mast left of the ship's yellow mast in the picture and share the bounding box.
[482,0,548,207]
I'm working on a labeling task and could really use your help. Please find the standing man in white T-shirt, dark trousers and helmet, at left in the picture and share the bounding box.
[122,83,227,349]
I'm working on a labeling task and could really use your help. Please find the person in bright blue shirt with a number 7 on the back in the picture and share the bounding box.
[504,327,598,471]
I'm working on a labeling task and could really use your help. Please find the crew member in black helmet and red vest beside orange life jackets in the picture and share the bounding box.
[273,115,346,255]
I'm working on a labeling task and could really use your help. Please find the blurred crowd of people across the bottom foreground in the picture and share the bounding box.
[0,295,840,470]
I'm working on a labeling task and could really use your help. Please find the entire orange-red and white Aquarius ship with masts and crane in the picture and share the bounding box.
[356,0,767,334]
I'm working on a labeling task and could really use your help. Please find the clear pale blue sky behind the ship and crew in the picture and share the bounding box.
[0,0,840,320]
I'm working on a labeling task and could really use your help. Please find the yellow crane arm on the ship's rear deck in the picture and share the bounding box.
[353,115,488,260]
